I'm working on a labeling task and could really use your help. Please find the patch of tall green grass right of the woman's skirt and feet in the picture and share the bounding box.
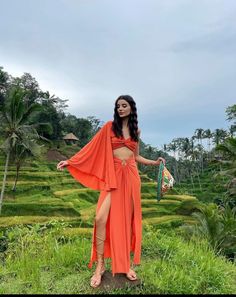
[140,228,235,294]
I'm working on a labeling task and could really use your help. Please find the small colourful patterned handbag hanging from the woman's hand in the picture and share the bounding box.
[157,161,175,201]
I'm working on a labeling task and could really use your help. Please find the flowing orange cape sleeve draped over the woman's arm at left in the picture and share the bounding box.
[66,121,116,191]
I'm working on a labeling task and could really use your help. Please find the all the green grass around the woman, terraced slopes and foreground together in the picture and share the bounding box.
[0,153,236,294]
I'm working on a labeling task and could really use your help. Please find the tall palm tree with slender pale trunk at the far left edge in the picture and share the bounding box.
[0,86,41,214]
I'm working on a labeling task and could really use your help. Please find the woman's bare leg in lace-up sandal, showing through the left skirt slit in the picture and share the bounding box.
[91,193,111,287]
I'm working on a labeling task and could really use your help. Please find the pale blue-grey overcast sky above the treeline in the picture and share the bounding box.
[0,0,236,149]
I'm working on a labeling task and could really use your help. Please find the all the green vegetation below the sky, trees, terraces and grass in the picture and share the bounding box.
[0,67,236,294]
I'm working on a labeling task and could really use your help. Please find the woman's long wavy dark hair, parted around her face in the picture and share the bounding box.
[112,95,138,141]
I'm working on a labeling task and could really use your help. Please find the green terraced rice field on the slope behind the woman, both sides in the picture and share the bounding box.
[0,153,198,233]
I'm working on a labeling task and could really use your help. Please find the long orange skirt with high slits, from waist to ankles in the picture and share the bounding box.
[88,156,142,276]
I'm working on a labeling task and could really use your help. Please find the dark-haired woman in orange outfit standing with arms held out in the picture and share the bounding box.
[57,95,165,288]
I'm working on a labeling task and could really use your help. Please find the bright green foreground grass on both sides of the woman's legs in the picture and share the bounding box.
[0,222,236,295]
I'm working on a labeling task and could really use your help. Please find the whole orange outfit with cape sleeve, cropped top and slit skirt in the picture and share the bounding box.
[67,121,142,276]
